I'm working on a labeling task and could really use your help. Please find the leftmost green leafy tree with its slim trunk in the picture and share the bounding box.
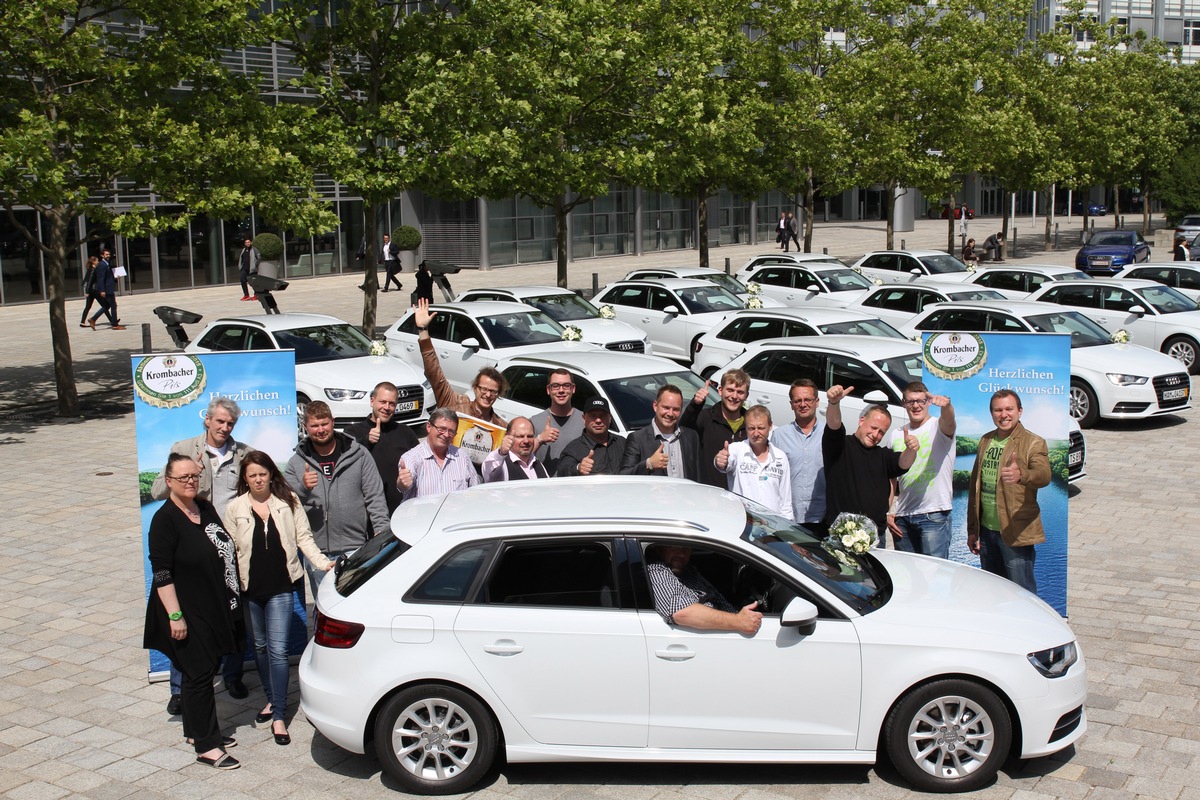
[0,0,320,415]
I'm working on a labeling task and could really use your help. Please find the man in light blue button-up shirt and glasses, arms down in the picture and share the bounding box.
[770,378,826,536]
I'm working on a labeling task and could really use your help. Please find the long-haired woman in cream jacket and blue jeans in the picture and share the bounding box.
[226,450,334,745]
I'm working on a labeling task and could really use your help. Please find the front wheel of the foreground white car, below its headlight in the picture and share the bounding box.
[883,679,1013,792]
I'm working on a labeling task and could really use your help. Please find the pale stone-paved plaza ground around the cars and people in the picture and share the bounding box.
[0,219,1200,800]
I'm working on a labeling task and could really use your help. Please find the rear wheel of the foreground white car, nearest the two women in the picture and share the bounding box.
[374,684,497,794]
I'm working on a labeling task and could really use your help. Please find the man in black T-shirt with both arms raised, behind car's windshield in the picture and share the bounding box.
[821,386,920,546]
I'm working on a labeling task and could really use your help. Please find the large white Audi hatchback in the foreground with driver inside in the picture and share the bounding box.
[300,476,1087,794]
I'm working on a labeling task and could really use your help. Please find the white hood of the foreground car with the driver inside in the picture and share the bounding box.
[857,551,1075,654]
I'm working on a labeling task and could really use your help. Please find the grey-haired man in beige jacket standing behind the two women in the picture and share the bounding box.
[150,397,253,715]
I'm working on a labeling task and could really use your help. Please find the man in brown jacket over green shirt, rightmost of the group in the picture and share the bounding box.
[967,389,1050,593]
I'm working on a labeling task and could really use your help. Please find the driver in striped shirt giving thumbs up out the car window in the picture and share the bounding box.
[646,545,762,636]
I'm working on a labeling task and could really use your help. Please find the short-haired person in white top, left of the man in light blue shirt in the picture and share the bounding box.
[713,405,794,519]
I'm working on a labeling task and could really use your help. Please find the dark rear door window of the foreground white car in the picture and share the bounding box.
[479,540,618,608]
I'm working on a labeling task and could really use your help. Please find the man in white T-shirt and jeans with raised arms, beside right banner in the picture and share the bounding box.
[886,380,956,559]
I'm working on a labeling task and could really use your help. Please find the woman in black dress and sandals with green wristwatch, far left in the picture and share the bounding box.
[142,453,245,770]
